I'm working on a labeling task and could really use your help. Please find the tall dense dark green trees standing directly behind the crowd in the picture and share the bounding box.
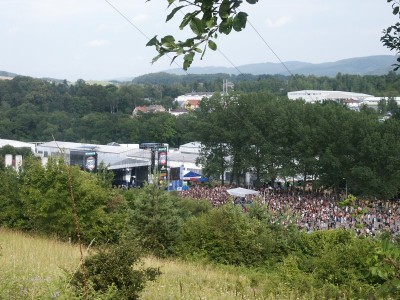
[193,93,400,198]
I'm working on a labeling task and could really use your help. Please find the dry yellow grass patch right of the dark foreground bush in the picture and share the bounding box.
[141,258,304,300]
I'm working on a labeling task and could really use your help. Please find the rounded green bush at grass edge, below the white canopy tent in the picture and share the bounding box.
[177,205,271,266]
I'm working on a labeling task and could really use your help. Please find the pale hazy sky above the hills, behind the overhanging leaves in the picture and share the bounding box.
[0,0,399,81]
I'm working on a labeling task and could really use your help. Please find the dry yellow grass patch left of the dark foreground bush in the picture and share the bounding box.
[0,228,80,299]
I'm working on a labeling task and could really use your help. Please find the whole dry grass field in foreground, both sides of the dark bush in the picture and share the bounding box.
[0,229,313,299]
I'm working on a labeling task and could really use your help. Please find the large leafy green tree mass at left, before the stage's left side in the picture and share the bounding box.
[15,158,127,244]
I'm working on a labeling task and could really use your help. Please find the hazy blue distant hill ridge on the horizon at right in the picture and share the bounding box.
[164,55,396,77]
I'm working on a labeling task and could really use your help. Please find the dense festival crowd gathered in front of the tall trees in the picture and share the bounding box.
[180,186,400,236]
